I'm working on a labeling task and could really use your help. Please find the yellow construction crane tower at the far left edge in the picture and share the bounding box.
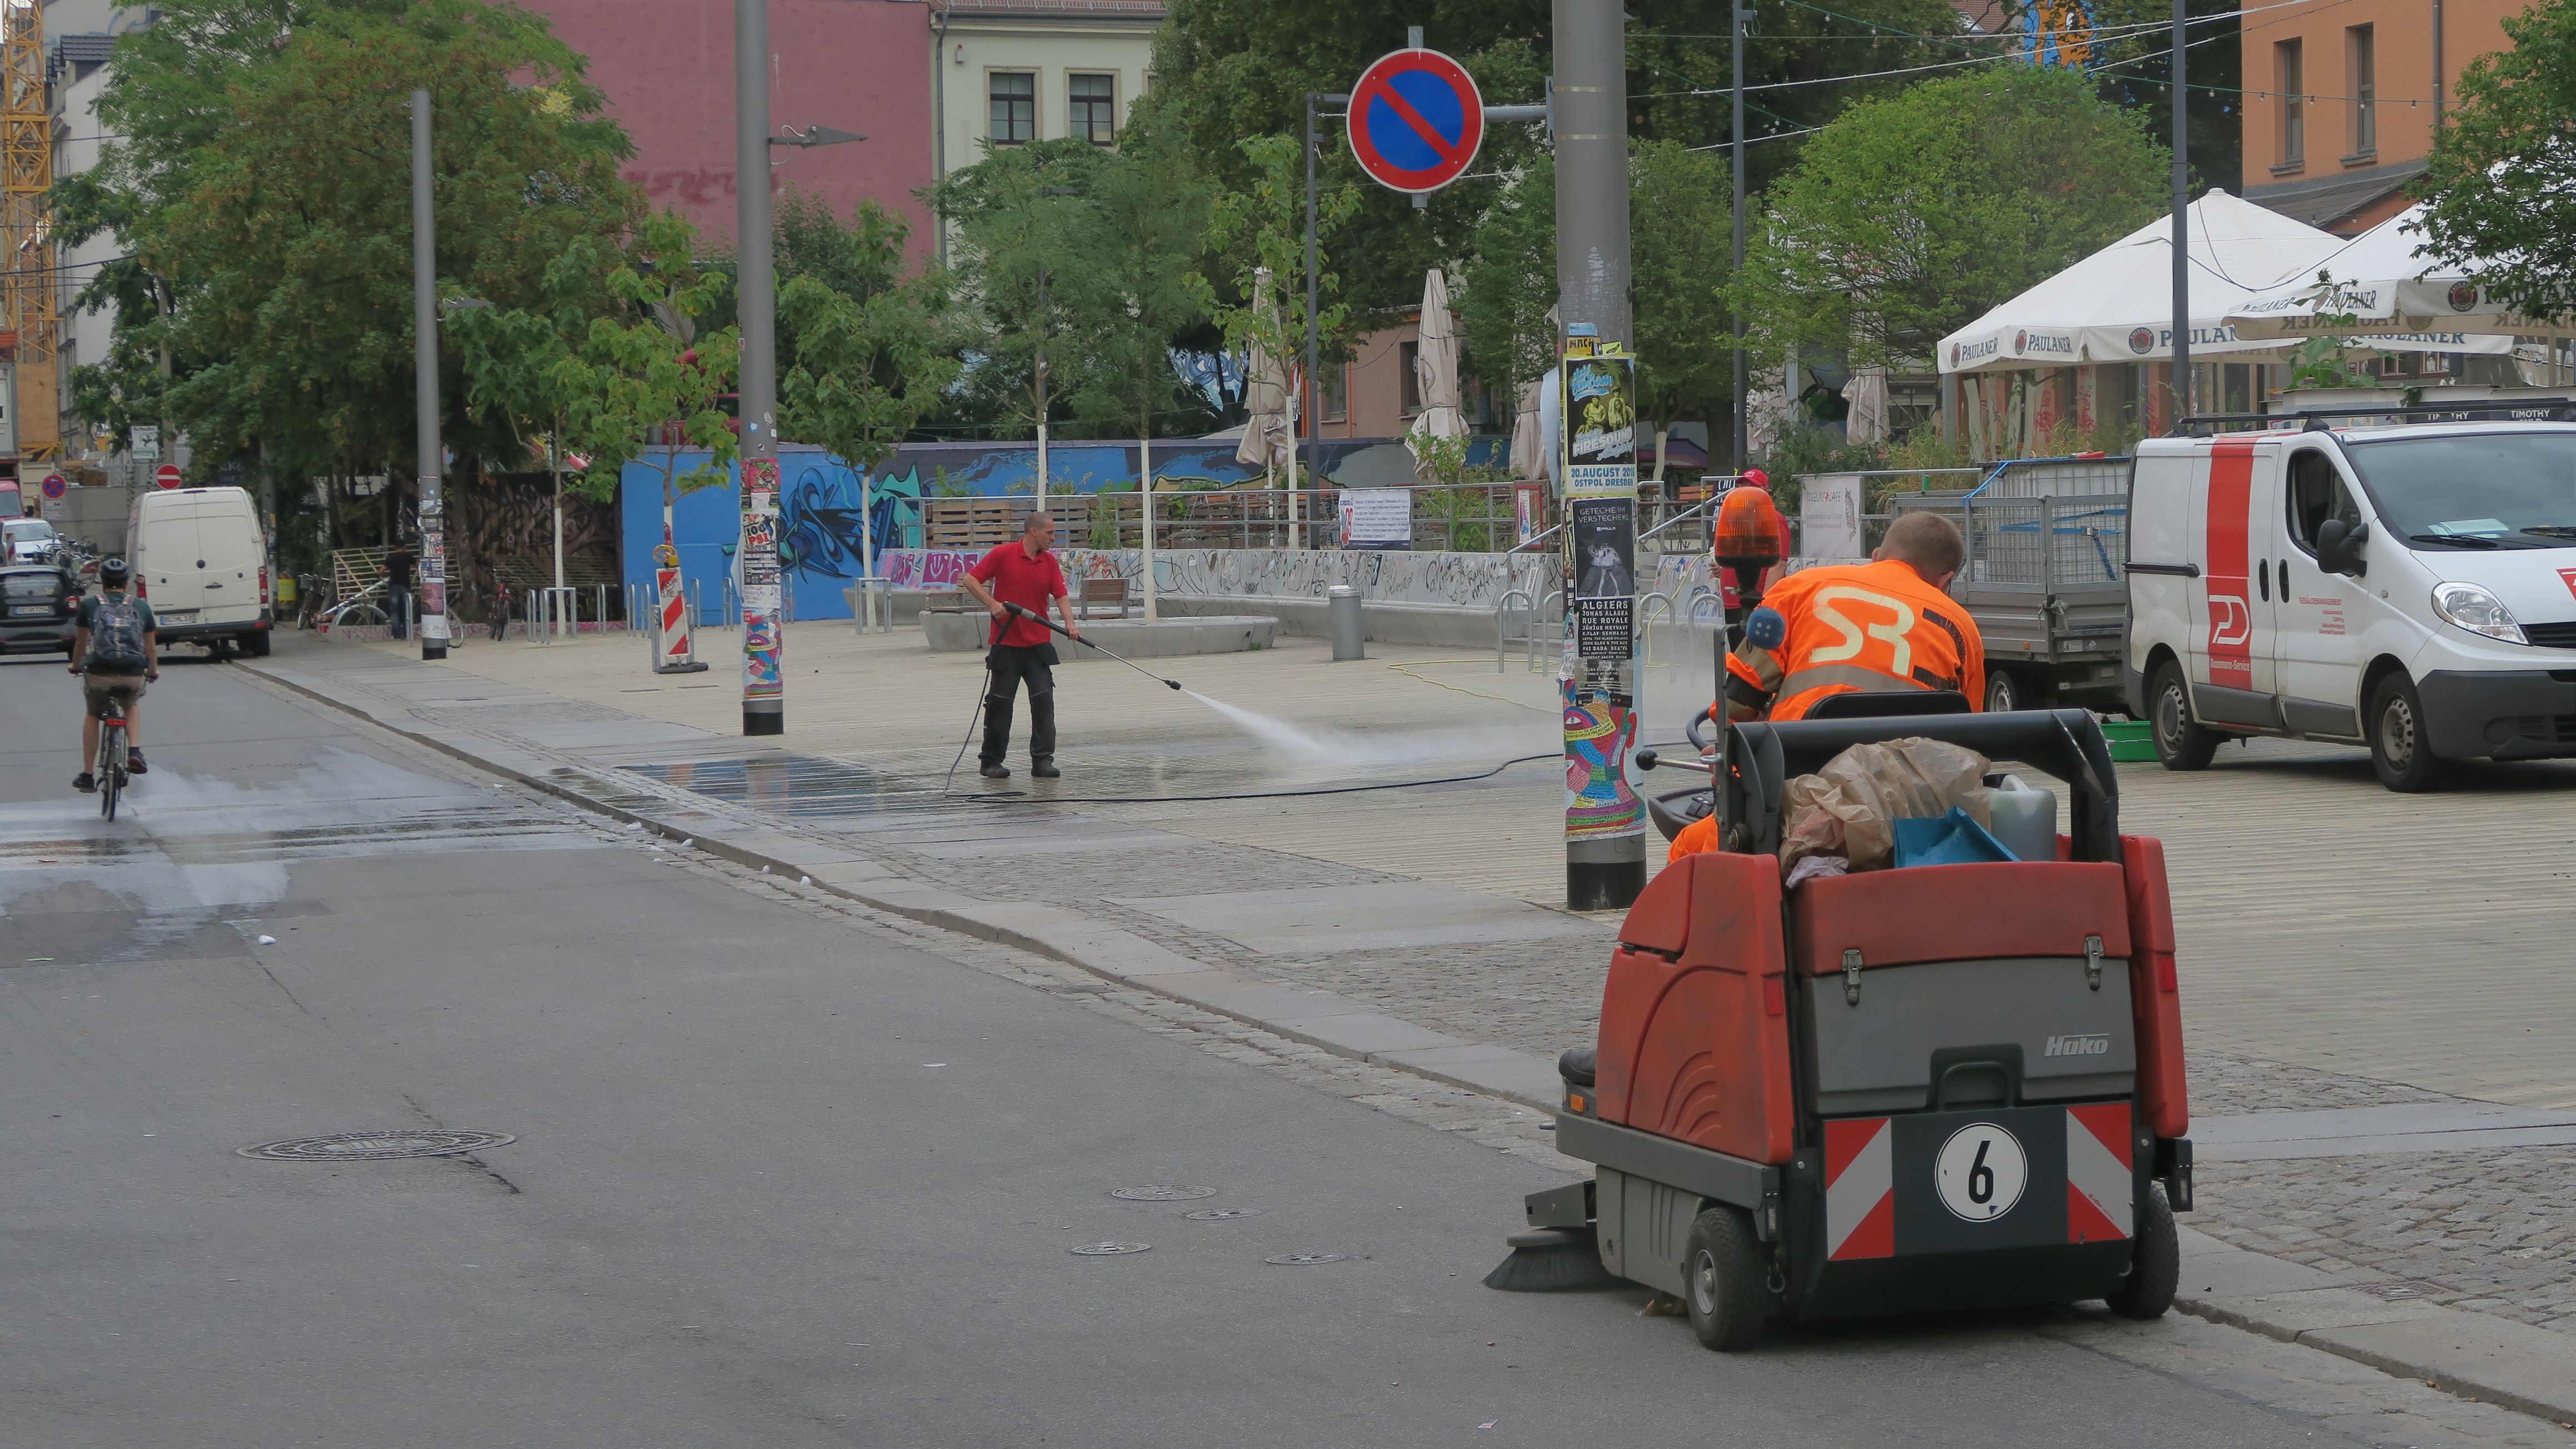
[0,0,62,473]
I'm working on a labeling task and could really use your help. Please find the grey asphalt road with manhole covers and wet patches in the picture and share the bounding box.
[0,659,2568,1449]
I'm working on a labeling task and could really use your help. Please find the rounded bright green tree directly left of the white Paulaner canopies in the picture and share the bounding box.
[1731,67,2166,368]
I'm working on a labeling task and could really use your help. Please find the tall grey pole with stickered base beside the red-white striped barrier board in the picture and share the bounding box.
[734,0,788,734]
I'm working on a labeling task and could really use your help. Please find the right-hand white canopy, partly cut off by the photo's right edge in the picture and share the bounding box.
[2226,206,2576,352]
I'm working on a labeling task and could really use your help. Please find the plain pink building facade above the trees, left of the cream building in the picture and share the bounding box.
[523,0,932,252]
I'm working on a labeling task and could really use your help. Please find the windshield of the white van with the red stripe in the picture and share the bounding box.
[2344,432,2576,548]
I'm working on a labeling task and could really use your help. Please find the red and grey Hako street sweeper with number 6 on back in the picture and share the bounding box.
[1486,710,2192,1351]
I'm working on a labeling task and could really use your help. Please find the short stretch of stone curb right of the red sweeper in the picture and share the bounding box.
[2174,1228,2576,1428]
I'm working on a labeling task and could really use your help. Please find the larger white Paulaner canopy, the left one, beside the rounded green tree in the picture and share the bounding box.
[1937,190,2512,373]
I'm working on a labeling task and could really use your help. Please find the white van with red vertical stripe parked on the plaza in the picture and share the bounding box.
[2125,422,2576,790]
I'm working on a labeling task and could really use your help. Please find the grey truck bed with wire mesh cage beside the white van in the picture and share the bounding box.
[1888,456,2133,710]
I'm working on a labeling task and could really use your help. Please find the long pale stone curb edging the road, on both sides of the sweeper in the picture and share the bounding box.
[234,659,2576,1426]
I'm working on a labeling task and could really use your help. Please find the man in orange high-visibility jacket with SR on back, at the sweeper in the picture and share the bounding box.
[1667,512,1986,860]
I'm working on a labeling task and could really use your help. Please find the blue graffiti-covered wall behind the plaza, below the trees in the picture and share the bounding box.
[618,437,1512,620]
